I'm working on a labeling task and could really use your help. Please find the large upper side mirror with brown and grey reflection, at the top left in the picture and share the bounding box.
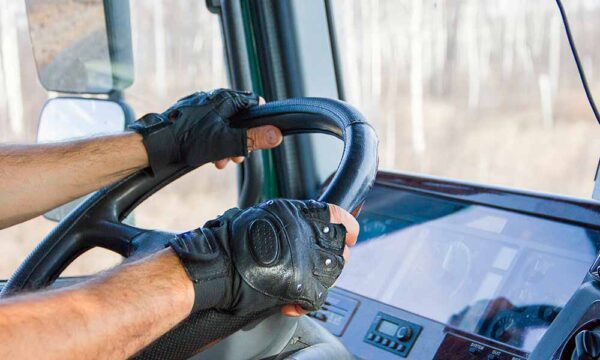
[25,0,133,94]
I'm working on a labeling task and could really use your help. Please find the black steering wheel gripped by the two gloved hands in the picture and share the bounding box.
[1,98,378,359]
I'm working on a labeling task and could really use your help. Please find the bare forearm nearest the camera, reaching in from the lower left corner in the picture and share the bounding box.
[0,250,194,359]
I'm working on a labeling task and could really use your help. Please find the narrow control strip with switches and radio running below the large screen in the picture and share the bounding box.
[322,288,528,360]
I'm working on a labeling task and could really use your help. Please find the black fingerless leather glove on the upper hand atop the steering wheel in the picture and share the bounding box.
[129,89,258,173]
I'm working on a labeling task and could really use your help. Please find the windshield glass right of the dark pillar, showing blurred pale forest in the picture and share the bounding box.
[333,0,600,198]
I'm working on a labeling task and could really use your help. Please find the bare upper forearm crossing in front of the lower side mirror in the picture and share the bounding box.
[0,133,148,229]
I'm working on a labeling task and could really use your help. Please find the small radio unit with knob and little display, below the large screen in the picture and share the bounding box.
[364,312,422,357]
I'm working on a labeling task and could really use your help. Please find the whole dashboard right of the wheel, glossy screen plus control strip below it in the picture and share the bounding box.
[311,173,600,360]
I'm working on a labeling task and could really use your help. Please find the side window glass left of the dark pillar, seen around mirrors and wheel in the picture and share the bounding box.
[0,0,237,279]
